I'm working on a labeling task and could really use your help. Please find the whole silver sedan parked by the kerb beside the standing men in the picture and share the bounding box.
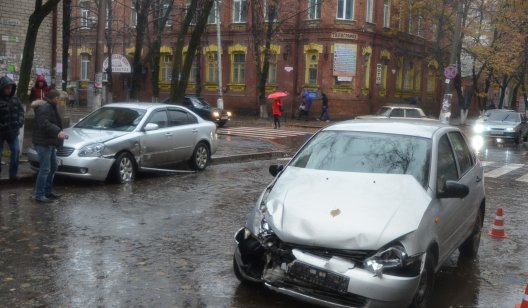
[28,103,218,183]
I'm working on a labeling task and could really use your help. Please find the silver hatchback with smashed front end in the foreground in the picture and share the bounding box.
[234,120,485,307]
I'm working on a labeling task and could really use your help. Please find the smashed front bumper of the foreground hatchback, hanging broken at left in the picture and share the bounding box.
[234,228,420,307]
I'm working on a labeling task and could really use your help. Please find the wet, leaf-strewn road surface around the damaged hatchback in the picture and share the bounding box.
[0,134,528,307]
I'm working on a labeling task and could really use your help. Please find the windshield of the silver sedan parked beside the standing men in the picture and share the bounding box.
[74,107,146,132]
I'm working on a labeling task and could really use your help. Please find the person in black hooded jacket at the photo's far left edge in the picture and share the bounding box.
[0,76,24,181]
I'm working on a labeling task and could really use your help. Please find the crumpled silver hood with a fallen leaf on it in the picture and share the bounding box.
[265,167,431,250]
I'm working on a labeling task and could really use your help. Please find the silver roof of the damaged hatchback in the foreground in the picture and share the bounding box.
[323,118,452,138]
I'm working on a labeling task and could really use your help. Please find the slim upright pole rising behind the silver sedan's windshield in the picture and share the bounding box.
[94,0,106,109]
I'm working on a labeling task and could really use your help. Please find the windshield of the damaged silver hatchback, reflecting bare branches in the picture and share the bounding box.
[291,131,431,187]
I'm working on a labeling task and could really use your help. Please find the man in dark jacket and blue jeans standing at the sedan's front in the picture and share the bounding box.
[31,90,64,203]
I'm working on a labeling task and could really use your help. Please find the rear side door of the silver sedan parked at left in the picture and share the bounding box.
[167,107,199,162]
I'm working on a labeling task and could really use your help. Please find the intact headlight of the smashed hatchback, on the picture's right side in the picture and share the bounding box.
[363,245,423,277]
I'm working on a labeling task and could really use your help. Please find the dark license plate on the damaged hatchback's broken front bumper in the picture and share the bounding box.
[288,261,350,293]
